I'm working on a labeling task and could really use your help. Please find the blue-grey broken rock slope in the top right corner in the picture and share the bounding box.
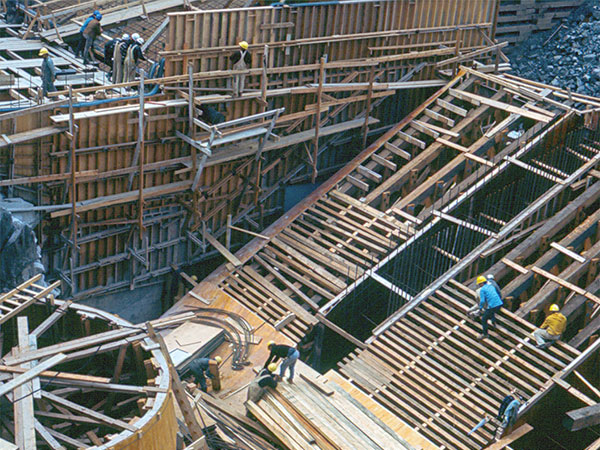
[506,0,600,97]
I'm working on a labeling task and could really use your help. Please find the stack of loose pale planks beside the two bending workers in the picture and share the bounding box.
[248,370,415,450]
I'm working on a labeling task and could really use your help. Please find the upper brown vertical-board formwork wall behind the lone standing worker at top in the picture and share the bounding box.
[161,0,497,124]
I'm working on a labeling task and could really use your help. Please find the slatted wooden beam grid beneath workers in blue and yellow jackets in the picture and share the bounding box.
[340,285,578,449]
